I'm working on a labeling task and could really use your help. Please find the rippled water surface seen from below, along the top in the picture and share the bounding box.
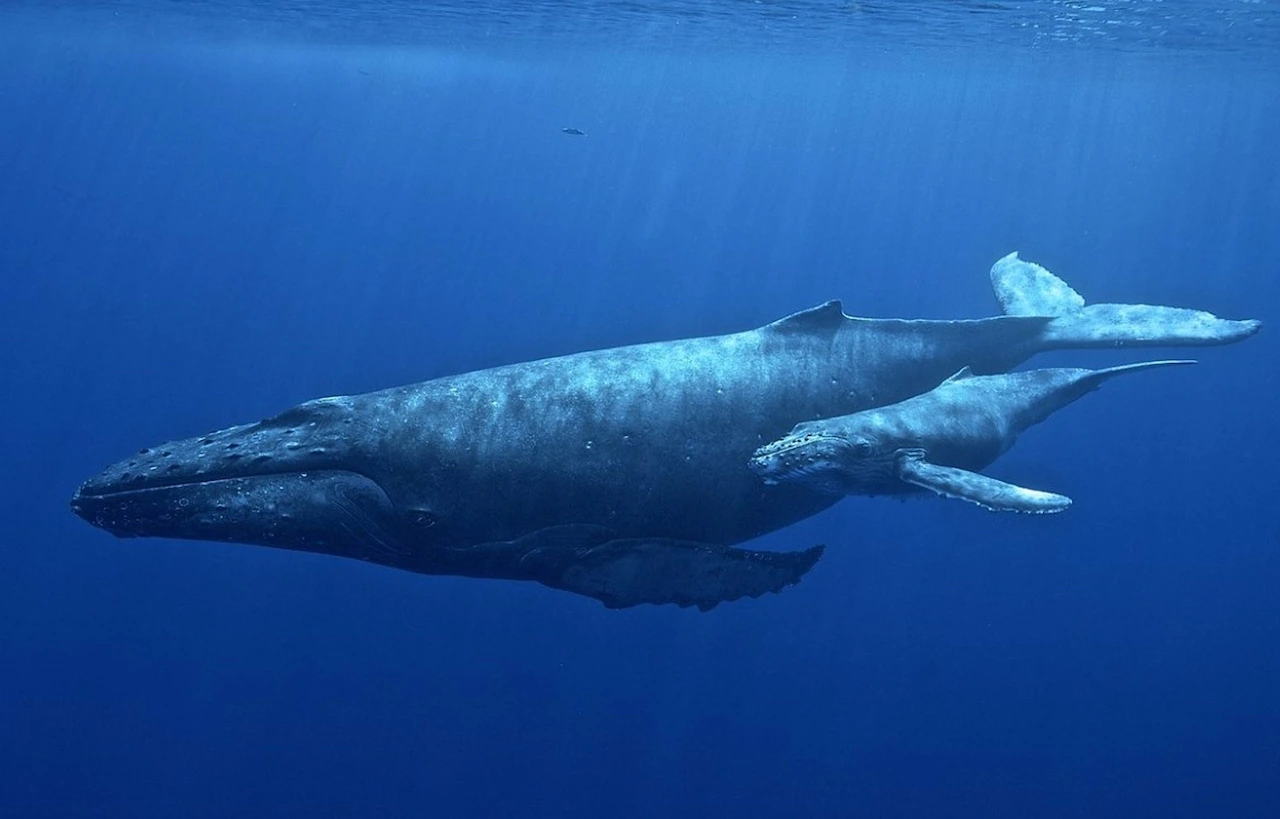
[5,0,1280,58]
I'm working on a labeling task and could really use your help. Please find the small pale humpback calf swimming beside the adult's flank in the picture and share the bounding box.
[750,361,1194,514]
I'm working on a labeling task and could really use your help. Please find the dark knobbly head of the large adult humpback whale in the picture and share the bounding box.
[70,398,436,564]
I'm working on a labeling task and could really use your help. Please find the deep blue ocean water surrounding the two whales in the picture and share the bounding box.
[0,0,1280,816]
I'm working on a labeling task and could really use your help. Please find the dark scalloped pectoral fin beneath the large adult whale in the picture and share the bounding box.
[521,526,823,612]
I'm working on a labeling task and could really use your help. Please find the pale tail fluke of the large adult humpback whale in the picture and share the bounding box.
[991,253,1262,348]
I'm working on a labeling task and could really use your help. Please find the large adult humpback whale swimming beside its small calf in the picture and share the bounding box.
[72,253,1260,609]
